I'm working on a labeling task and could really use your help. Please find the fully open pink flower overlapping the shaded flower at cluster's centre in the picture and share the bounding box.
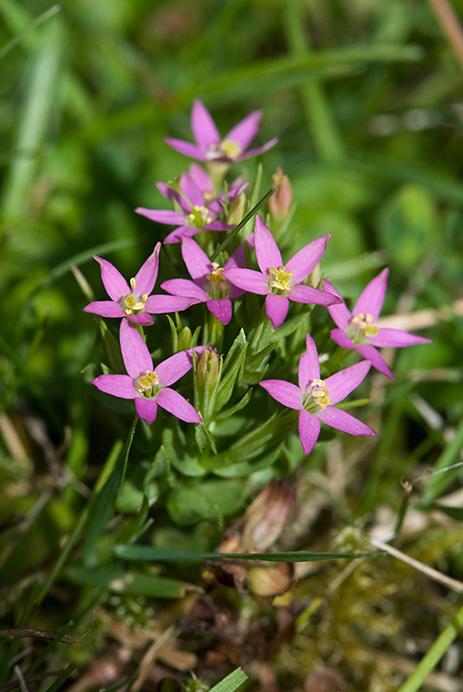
[223,216,340,329]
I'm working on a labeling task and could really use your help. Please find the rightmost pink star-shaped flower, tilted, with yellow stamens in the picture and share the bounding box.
[323,269,431,380]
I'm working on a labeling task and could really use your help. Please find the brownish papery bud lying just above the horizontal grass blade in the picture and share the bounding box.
[243,480,296,551]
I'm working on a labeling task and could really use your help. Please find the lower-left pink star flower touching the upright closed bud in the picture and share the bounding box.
[92,320,204,424]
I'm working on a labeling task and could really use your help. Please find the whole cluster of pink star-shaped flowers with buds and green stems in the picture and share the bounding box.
[84,101,429,454]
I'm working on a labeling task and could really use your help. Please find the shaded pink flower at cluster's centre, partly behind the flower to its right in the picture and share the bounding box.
[161,236,250,324]
